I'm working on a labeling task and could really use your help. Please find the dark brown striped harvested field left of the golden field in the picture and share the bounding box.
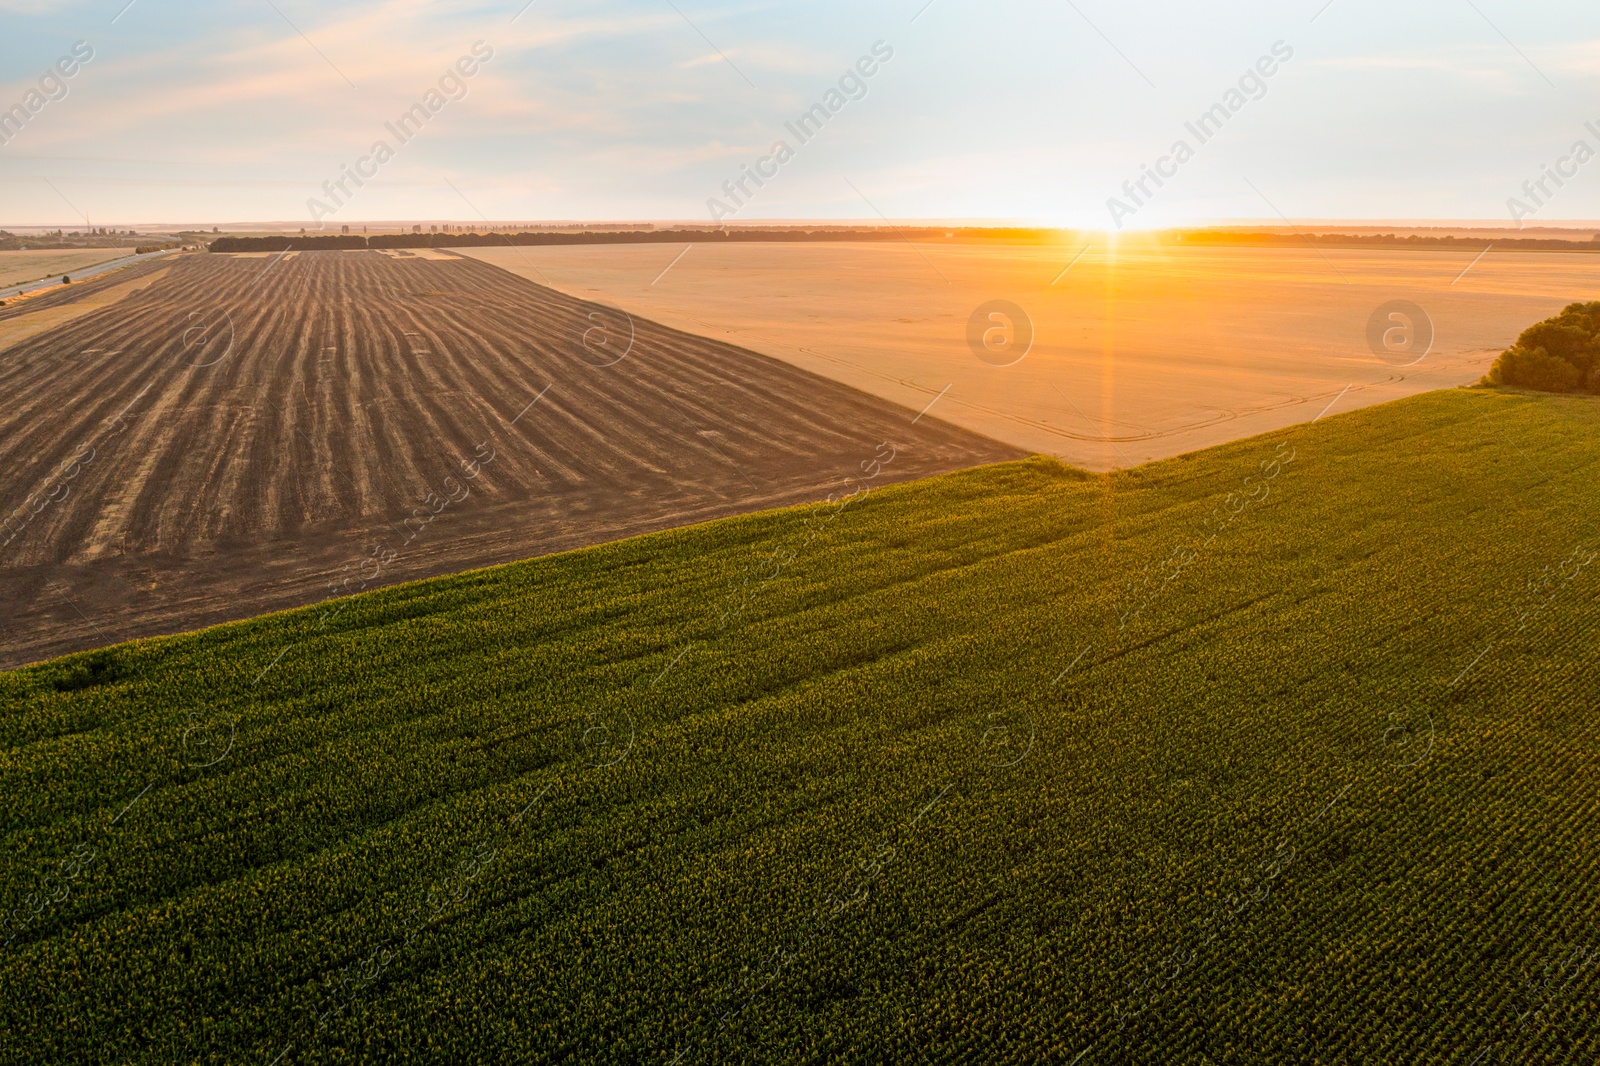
[0,251,1021,666]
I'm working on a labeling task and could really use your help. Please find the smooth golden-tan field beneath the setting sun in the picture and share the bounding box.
[462,240,1600,471]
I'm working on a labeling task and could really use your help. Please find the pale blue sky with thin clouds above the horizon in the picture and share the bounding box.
[0,0,1600,229]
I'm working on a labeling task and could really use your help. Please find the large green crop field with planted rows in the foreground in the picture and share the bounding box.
[0,389,1600,1066]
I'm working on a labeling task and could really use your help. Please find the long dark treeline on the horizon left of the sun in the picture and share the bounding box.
[211,226,1051,251]
